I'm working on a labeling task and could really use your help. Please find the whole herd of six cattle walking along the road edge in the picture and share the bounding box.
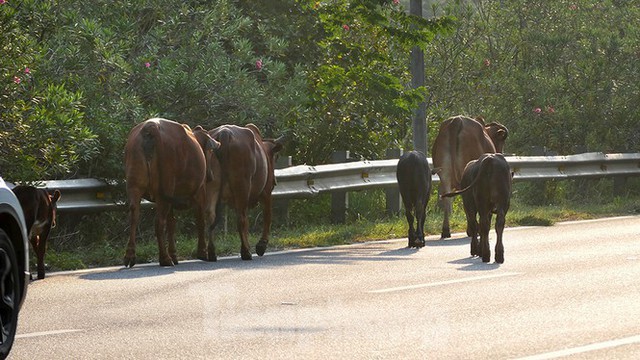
[13,116,512,279]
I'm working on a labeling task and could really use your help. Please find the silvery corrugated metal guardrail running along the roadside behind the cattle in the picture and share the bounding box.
[35,153,640,212]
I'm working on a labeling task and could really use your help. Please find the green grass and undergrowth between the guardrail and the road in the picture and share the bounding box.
[41,180,640,271]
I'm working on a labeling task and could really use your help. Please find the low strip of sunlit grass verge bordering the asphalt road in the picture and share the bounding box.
[41,191,640,271]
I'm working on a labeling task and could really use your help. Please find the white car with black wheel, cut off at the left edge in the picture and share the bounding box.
[0,177,31,359]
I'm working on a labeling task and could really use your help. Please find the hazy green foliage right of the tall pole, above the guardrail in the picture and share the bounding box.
[427,0,640,154]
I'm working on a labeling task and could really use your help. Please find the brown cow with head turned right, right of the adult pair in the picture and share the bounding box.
[207,124,282,261]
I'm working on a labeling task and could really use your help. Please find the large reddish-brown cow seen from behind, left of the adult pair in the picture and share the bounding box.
[124,118,219,267]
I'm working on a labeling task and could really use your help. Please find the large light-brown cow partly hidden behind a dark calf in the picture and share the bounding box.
[431,115,509,239]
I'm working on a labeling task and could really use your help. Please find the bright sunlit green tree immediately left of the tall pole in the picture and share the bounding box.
[290,0,447,163]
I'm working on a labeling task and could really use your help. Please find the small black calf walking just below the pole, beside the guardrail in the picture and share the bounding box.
[396,151,431,248]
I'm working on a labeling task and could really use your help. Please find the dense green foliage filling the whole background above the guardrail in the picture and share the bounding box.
[0,0,640,181]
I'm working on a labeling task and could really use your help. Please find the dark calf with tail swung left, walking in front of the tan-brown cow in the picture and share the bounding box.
[442,154,513,264]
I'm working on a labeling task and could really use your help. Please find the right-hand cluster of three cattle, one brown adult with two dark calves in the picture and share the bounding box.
[396,116,513,263]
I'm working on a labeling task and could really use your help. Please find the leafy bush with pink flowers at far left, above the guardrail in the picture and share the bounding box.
[0,0,99,181]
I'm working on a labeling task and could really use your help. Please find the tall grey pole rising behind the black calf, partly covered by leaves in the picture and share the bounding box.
[409,0,427,155]
